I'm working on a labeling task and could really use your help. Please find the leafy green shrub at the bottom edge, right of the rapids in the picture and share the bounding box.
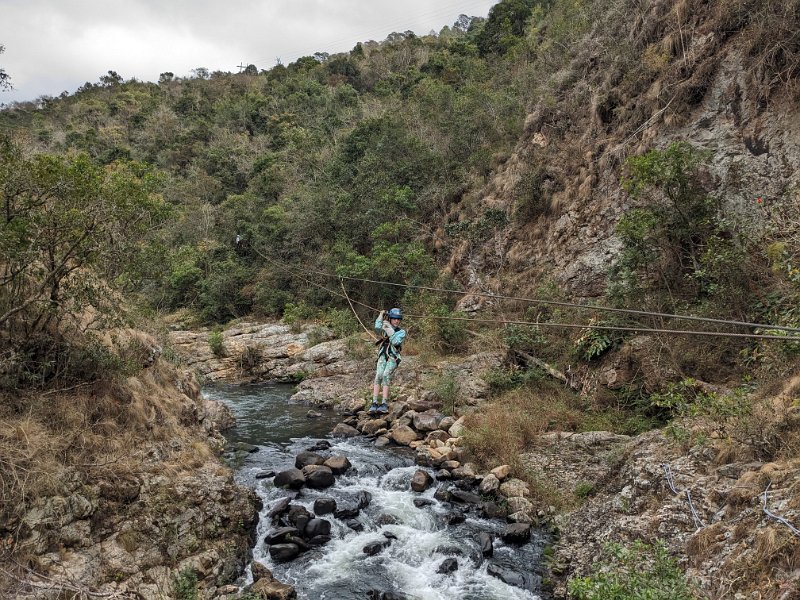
[568,541,696,600]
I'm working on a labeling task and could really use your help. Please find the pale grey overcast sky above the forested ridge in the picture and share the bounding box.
[0,0,497,103]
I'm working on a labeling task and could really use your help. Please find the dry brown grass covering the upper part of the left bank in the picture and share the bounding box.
[0,346,212,555]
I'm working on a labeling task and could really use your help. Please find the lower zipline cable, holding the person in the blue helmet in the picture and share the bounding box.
[254,248,800,342]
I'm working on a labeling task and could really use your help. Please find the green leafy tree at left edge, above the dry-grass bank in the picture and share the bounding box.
[0,138,165,344]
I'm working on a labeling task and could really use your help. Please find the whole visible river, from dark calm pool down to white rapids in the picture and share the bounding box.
[204,385,545,600]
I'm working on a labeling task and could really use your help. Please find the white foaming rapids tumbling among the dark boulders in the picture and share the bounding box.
[241,440,539,600]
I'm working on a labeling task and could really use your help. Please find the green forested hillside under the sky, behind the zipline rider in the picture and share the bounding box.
[3,1,541,322]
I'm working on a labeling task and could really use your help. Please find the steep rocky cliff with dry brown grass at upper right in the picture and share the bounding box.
[450,0,800,297]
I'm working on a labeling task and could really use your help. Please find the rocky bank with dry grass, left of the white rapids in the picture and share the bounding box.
[0,334,258,598]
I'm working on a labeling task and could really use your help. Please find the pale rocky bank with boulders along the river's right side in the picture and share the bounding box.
[170,325,800,600]
